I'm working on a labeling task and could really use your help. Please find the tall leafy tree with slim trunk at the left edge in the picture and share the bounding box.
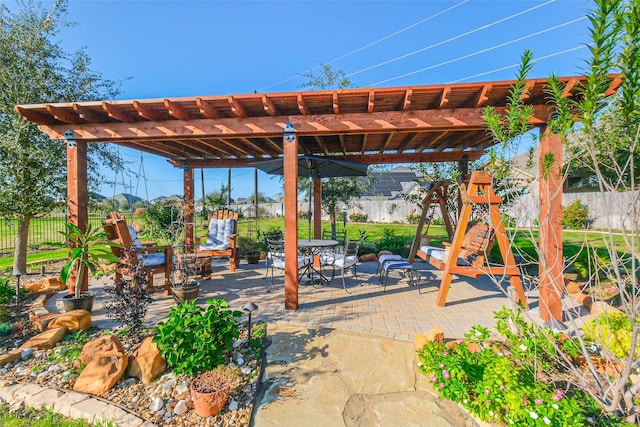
[0,0,120,271]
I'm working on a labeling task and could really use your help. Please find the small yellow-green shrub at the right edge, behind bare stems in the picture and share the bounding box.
[582,313,638,359]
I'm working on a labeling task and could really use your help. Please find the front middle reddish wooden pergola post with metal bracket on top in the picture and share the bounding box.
[283,122,298,310]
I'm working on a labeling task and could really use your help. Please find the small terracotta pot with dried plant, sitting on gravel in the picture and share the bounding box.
[190,366,231,417]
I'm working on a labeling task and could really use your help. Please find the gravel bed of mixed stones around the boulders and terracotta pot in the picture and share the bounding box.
[0,325,262,426]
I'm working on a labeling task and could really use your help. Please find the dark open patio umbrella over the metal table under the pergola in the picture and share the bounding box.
[249,155,369,239]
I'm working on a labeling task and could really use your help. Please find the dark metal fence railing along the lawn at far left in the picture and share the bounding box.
[0,214,106,256]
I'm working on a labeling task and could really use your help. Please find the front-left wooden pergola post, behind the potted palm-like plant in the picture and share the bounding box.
[65,137,89,293]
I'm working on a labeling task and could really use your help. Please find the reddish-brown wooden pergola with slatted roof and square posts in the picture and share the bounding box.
[15,77,620,320]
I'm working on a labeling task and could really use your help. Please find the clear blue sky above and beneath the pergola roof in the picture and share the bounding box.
[44,0,592,198]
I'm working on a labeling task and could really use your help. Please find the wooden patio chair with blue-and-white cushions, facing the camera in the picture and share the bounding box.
[197,210,240,271]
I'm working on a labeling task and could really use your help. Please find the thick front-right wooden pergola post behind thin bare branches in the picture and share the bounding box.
[539,126,564,322]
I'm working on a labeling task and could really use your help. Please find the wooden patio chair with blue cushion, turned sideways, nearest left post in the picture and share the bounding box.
[102,215,173,295]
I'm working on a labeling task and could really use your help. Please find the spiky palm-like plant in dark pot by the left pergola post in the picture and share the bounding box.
[49,223,119,312]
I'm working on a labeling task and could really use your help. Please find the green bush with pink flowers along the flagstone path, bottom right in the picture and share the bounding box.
[419,309,626,427]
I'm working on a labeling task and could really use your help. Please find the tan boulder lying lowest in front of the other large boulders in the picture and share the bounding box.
[73,352,128,395]
